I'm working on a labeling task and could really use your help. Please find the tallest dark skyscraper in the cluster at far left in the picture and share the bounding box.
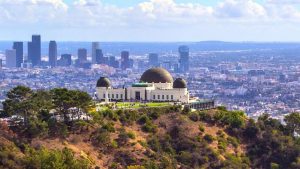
[28,35,41,66]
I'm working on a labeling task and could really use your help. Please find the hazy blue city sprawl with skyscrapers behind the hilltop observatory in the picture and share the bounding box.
[0,35,300,119]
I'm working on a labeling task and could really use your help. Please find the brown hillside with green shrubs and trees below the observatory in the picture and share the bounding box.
[0,87,300,169]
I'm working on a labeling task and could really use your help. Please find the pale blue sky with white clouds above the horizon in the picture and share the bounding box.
[0,0,300,41]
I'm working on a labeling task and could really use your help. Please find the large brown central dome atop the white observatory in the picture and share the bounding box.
[140,67,173,83]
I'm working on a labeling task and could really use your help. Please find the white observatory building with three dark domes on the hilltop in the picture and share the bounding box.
[96,68,190,103]
